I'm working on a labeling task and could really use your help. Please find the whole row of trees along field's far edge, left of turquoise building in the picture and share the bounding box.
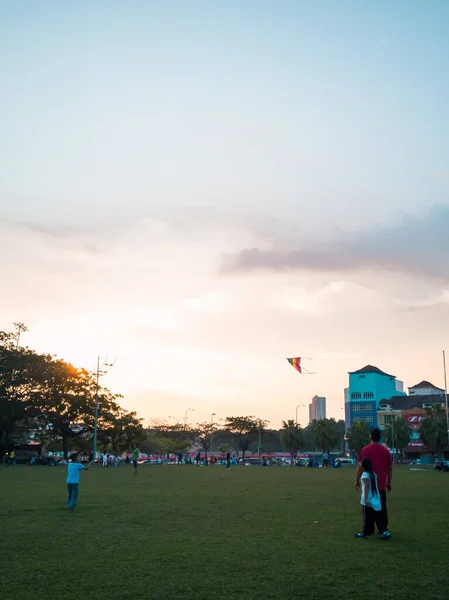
[0,324,344,457]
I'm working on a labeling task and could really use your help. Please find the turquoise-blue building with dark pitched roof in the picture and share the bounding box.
[345,365,406,429]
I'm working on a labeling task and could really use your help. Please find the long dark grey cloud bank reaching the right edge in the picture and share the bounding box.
[221,206,449,280]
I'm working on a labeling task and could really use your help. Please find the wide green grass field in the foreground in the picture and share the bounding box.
[0,466,449,600]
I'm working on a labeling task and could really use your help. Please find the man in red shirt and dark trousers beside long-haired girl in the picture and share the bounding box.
[355,427,393,540]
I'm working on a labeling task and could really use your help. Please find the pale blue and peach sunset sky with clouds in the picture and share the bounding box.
[0,0,449,427]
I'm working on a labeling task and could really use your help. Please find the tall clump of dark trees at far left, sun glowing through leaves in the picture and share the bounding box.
[0,323,149,457]
